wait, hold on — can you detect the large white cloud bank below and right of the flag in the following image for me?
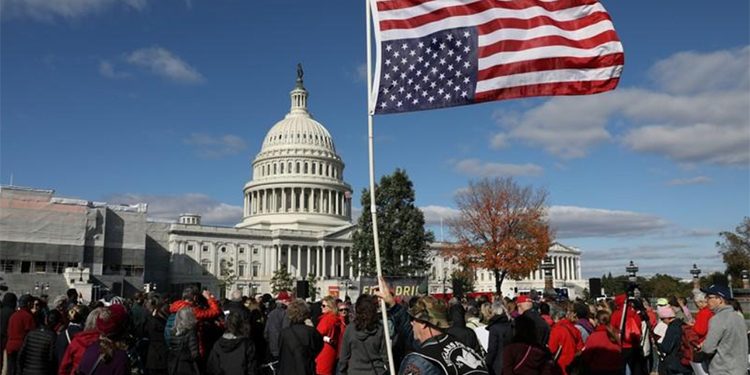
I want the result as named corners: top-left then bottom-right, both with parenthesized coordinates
top-left (490, 47), bottom-right (750, 165)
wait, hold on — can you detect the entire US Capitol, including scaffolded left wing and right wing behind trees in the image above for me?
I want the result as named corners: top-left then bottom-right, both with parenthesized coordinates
top-left (0, 73), bottom-right (587, 298)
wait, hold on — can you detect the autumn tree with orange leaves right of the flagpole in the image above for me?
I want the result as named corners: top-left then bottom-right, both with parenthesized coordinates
top-left (449, 177), bottom-right (553, 293)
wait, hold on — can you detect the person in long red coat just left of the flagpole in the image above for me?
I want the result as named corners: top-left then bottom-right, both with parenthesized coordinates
top-left (315, 296), bottom-right (343, 375)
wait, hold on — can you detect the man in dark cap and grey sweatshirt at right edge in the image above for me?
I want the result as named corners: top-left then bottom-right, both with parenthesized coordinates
top-left (701, 284), bottom-right (747, 375)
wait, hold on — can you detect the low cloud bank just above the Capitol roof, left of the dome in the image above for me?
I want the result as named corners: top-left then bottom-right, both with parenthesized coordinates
top-left (105, 193), bottom-right (242, 226)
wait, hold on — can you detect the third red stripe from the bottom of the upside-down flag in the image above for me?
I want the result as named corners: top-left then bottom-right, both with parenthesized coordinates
top-left (479, 30), bottom-right (617, 57)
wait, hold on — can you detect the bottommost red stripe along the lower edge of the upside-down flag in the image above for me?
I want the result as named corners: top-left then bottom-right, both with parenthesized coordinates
top-left (474, 78), bottom-right (620, 102)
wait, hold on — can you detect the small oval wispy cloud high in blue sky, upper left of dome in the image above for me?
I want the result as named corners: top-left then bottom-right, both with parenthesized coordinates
top-left (126, 47), bottom-right (205, 83)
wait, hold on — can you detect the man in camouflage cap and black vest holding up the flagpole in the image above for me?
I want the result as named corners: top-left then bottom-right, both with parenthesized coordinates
top-left (377, 279), bottom-right (487, 375)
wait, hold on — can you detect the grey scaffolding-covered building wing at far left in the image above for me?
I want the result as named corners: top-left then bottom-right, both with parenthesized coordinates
top-left (0, 186), bottom-right (147, 296)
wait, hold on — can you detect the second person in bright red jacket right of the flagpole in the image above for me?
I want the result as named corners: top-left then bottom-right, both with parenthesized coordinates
top-left (581, 310), bottom-right (623, 375)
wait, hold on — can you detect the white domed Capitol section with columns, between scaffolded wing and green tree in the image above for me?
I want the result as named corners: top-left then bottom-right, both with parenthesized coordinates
top-left (161, 74), bottom-right (355, 294)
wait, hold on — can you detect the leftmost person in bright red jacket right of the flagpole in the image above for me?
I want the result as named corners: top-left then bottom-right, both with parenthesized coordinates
top-left (547, 305), bottom-right (583, 375)
